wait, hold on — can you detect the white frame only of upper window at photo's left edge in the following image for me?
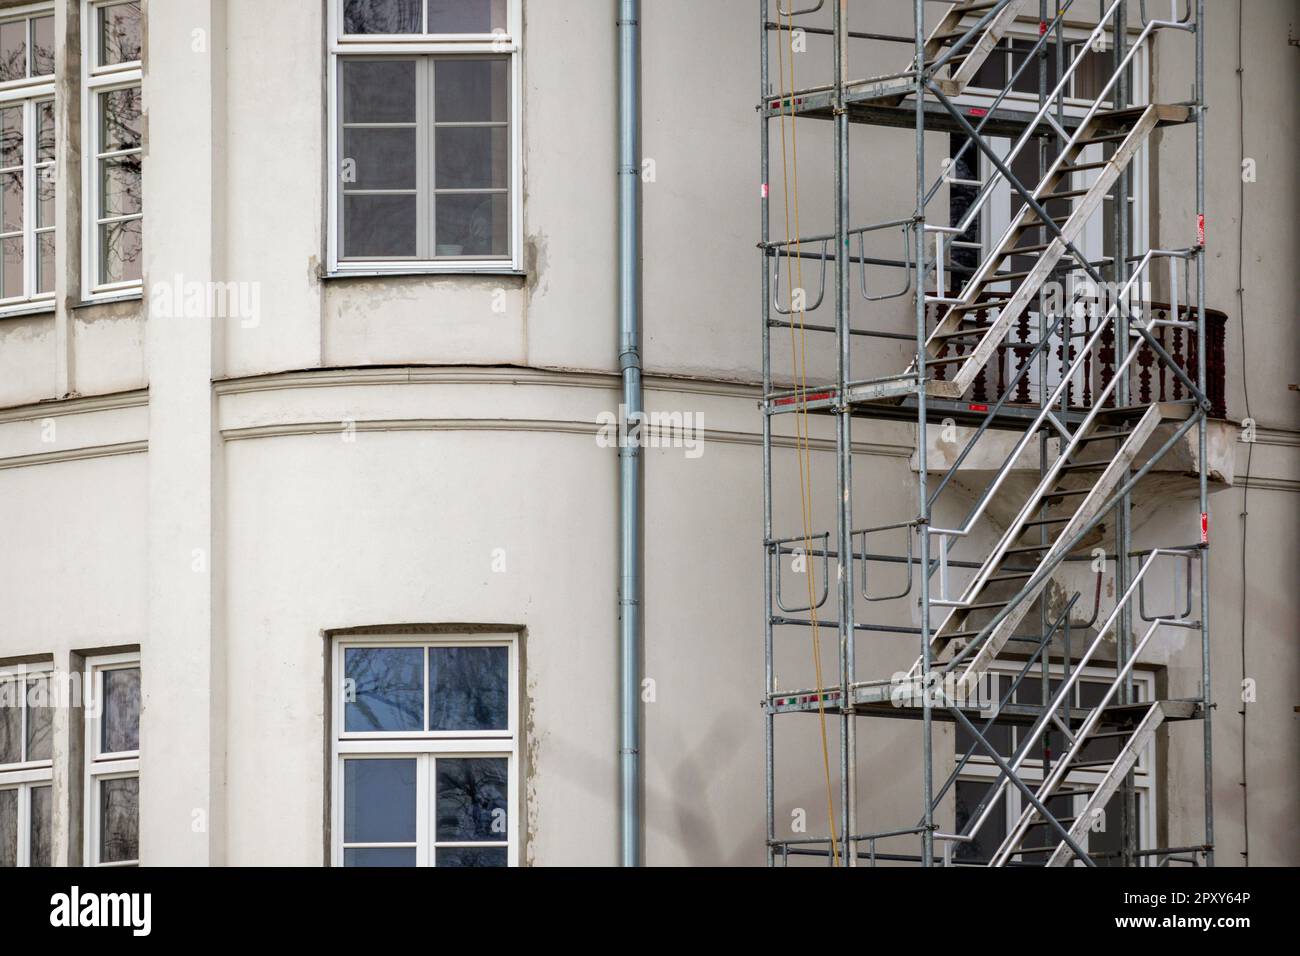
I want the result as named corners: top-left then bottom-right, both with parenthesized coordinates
top-left (0, 3), bottom-right (59, 315)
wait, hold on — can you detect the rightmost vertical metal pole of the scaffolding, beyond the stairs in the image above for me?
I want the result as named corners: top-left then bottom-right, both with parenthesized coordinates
top-left (1196, 0), bottom-right (1214, 866)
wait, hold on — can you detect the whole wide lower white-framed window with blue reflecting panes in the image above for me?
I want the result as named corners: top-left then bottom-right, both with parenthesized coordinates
top-left (330, 636), bottom-right (519, 866)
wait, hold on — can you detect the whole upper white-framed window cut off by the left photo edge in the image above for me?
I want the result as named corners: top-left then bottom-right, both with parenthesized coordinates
top-left (0, 3), bottom-right (55, 311)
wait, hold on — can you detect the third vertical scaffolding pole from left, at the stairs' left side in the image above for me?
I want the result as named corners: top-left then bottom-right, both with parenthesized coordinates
top-left (911, 0), bottom-right (944, 866)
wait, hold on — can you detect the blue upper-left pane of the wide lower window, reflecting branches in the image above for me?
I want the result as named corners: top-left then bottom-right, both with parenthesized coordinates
top-left (343, 648), bottom-right (424, 732)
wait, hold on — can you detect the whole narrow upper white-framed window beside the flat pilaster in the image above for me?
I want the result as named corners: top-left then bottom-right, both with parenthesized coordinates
top-left (82, 0), bottom-right (144, 299)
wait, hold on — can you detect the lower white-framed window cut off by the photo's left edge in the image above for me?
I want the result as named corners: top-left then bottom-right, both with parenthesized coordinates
top-left (0, 665), bottom-right (55, 868)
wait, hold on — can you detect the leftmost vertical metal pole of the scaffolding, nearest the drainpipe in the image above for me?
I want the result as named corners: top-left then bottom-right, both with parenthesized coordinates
top-left (758, 0), bottom-right (780, 866)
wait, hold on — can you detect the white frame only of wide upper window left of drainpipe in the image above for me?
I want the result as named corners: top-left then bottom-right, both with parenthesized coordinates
top-left (325, 0), bottom-right (524, 276)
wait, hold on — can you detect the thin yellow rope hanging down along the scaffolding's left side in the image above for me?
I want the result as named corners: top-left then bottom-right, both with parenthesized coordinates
top-left (776, 5), bottom-right (845, 866)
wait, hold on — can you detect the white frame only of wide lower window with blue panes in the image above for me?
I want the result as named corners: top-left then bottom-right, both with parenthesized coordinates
top-left (329, 633), bottom-right (523, 866)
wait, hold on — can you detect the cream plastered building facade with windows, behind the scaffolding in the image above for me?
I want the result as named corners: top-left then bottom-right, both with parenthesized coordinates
top-left (0, 0), bottom-right (1300, 865)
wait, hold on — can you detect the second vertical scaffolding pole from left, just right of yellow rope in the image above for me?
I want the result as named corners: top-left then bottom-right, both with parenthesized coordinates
top-left (833, 0), bottom-right (858, 866)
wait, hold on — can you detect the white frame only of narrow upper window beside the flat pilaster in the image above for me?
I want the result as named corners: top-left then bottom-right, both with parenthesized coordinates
top-left (81, 0), bottom-right (147, 302)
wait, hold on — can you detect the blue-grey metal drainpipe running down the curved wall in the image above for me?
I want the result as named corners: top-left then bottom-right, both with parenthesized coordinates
top-left (619, 0), bottom-right (644, 866)
